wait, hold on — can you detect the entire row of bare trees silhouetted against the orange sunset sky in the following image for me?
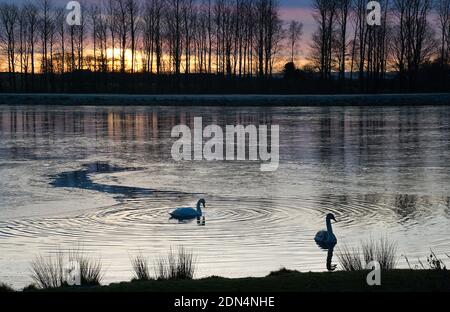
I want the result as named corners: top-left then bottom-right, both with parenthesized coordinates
top-left (0, 0), bottom-right (450, 92)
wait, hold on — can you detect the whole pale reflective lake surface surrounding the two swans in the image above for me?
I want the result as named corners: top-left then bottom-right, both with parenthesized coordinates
top-left (0, 106), bottom-right (450, 287)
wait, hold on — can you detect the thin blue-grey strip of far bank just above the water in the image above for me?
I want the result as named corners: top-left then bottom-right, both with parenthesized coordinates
top-left (0, 93), bottom-right (450, 107)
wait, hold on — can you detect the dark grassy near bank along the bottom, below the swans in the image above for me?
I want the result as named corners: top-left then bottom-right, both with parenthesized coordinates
top-left (37, 270), bottom-right (450, 293)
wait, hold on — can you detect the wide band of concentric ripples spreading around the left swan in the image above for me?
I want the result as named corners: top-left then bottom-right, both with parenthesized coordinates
top-left (0, 194), bottom-right (447, 244)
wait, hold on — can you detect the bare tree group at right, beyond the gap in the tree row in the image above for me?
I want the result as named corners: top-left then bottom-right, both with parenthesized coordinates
top-left (311, 0), bottom-right (450, 88)
